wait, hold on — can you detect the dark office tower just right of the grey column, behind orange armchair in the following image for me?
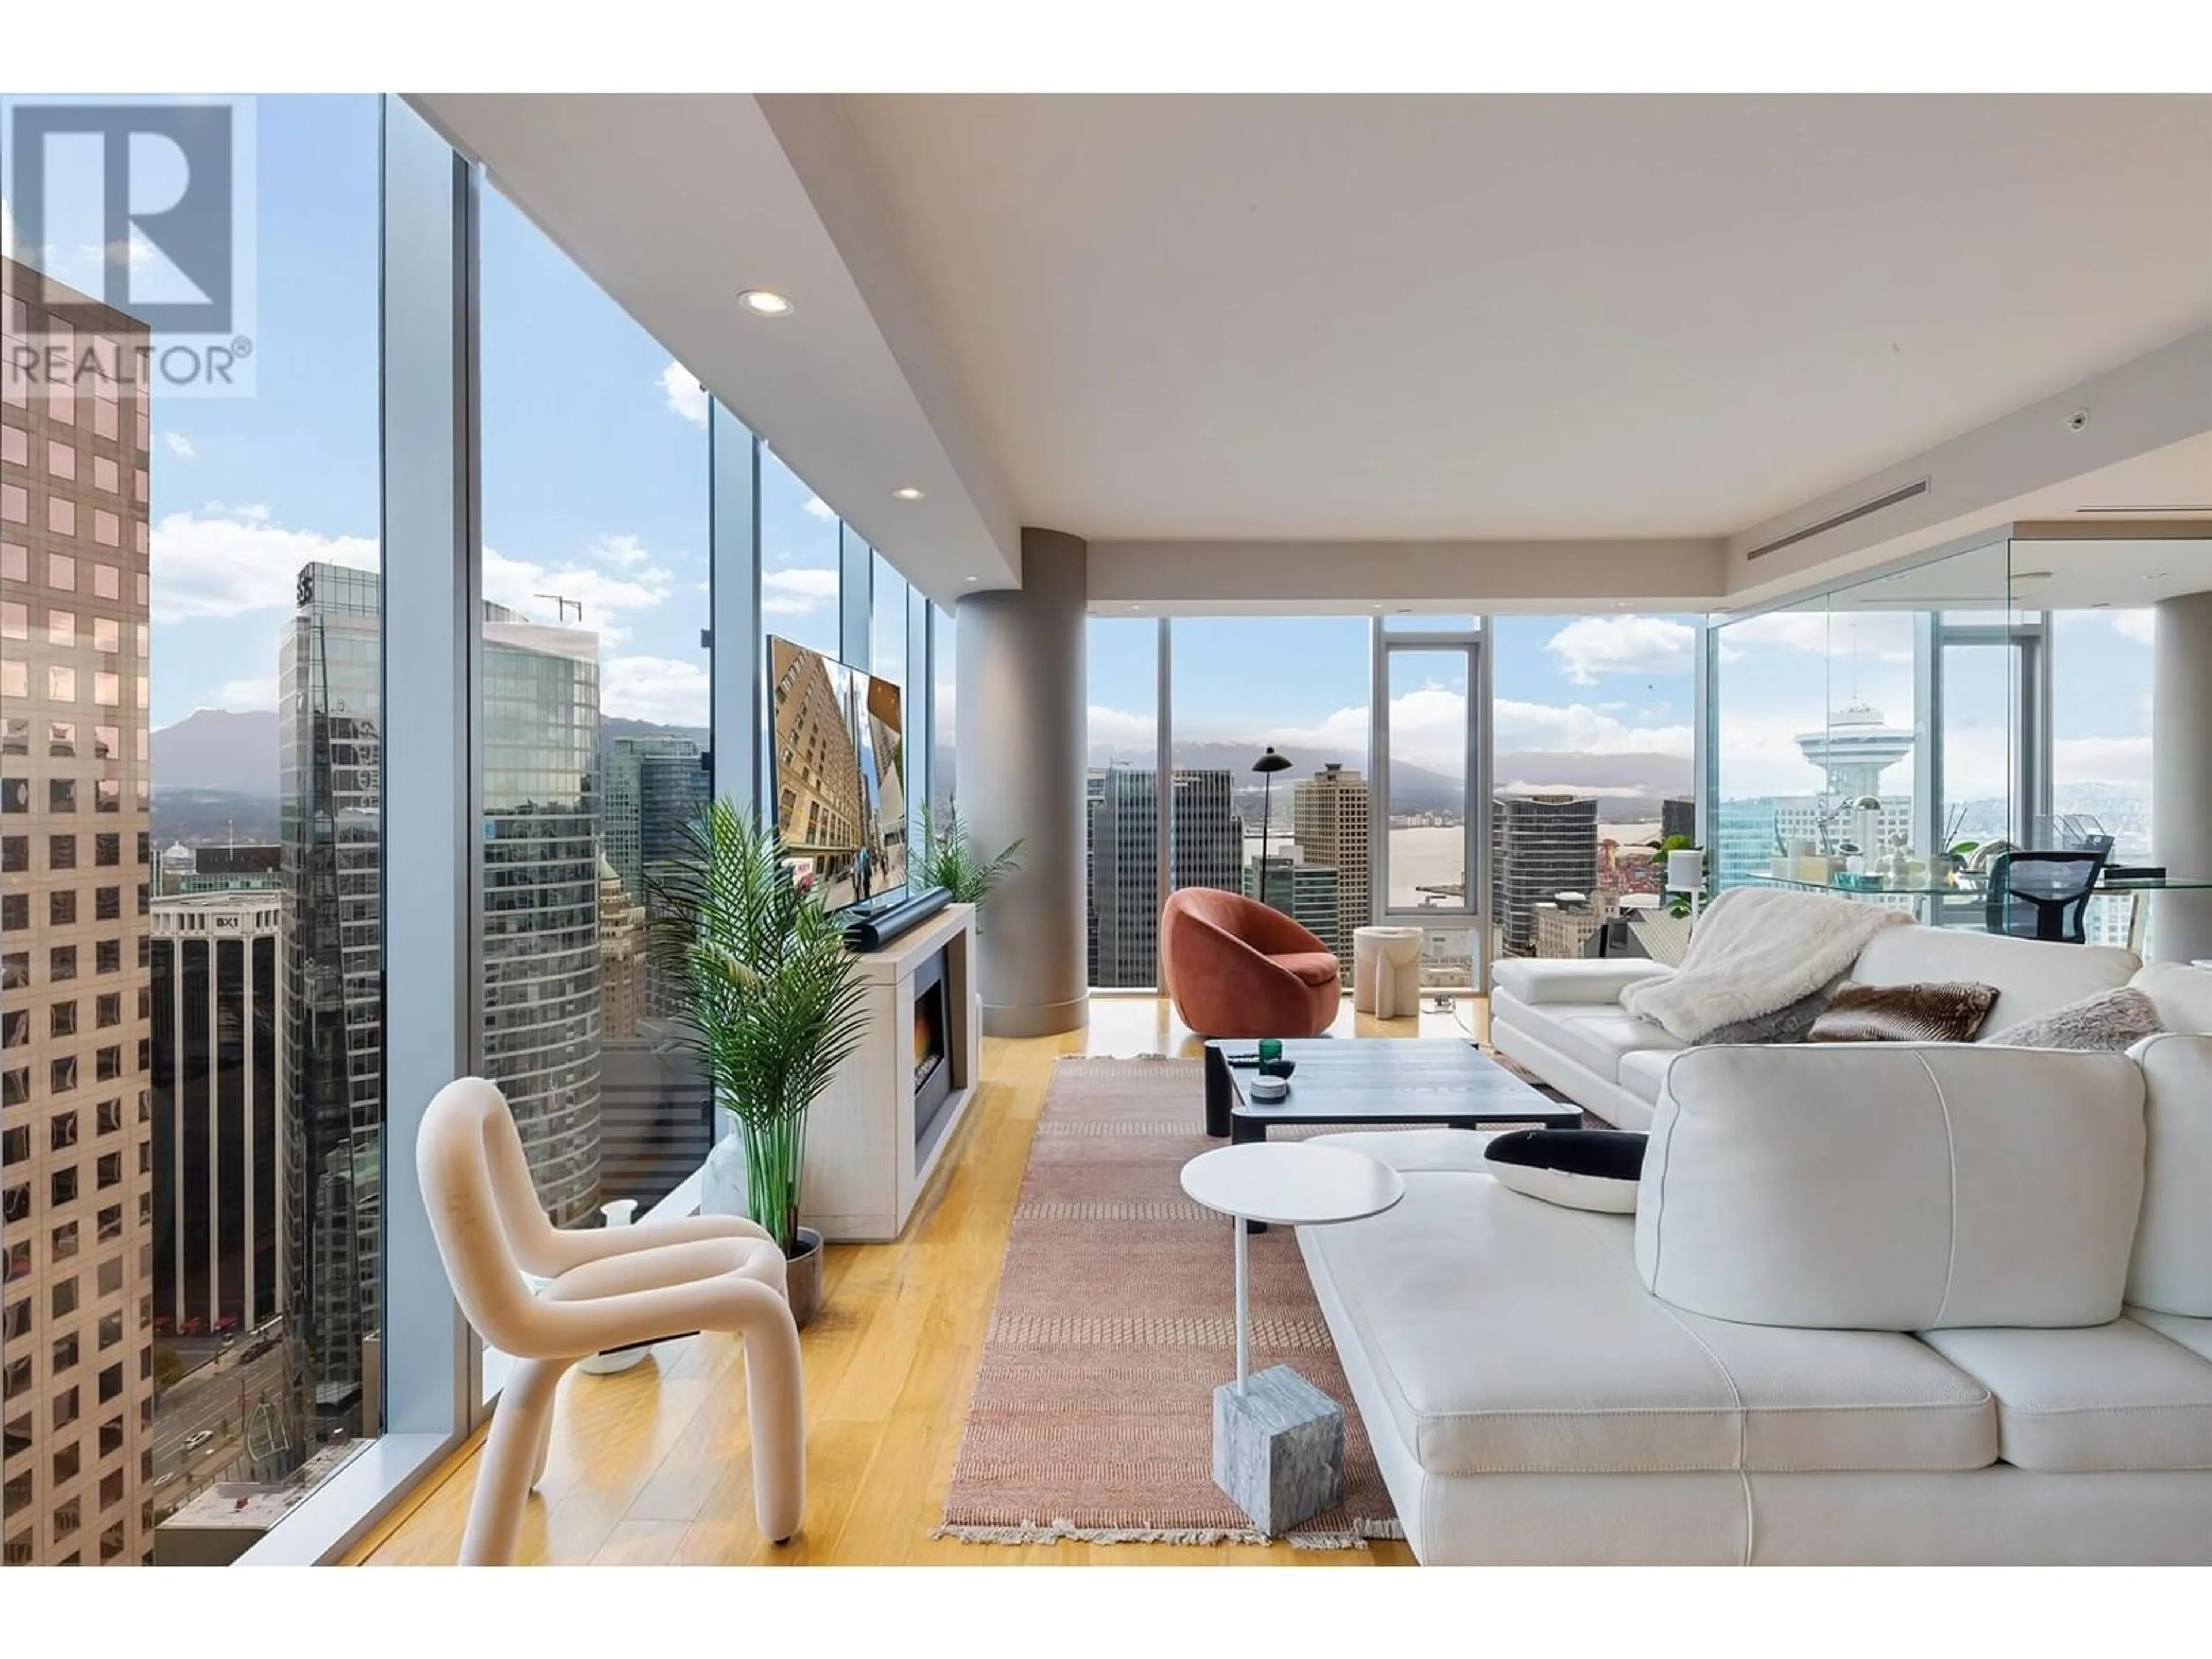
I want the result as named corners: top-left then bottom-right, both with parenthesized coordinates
top-left (1090, 766), bottom-right (1243, 988)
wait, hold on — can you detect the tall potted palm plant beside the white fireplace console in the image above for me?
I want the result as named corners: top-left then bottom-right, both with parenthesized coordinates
top-left (646, 798), bottom-right (867, 1325)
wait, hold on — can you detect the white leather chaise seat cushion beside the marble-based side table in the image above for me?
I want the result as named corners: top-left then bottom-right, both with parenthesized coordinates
top-left (1298, 1168), bottom-right (1998, 1478)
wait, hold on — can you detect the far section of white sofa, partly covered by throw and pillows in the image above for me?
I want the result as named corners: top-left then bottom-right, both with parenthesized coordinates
top-left (1491, 927), bottom-right (2212, 1128)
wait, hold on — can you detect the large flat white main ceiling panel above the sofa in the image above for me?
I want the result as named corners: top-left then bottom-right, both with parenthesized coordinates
top-left (838, 97), bottom-right (2212, 540)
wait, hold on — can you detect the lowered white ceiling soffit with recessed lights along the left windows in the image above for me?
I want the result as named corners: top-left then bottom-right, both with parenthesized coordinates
top-left (411, 93), bottom-right (1020, 604)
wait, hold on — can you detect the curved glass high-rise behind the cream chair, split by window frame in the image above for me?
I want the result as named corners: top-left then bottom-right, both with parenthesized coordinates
top-left (279, 564), bottom-right (600, 1433)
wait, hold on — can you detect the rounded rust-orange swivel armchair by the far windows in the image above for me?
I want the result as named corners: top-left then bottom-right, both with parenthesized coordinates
top-left (1159, 887), bottom-right (1343, 1037)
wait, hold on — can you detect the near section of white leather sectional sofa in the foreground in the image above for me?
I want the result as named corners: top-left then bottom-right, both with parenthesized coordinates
top-left (1298, 942), bottom-right (2212, 1564)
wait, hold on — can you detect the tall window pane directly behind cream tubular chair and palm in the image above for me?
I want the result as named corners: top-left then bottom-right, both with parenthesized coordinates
top-left (478, 184), bottom-right (712, 1389)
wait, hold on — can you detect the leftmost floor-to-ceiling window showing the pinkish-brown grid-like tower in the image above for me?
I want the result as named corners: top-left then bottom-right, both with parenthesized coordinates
top-left (0, 97), bottom-right (382, 1564)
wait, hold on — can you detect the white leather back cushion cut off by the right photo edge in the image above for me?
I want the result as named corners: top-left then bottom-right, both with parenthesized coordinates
top-left (2128, 1035), bottom-right (2212, 1319)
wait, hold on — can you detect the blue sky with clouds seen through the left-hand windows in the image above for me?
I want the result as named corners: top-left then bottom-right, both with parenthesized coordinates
top-left (13, 97), bottom-right (838, 728)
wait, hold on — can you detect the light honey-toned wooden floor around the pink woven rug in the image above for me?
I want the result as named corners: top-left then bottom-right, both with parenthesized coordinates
top-left (350, 998), bottom-right (1484, 1566)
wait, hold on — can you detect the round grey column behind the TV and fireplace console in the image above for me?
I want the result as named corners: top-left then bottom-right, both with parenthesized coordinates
top-left (953, 529), bottom-right (1090, 1037)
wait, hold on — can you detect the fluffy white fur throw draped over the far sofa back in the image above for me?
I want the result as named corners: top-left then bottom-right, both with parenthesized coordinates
top-left (1622, 887), bottom-right (1911, 1042)
